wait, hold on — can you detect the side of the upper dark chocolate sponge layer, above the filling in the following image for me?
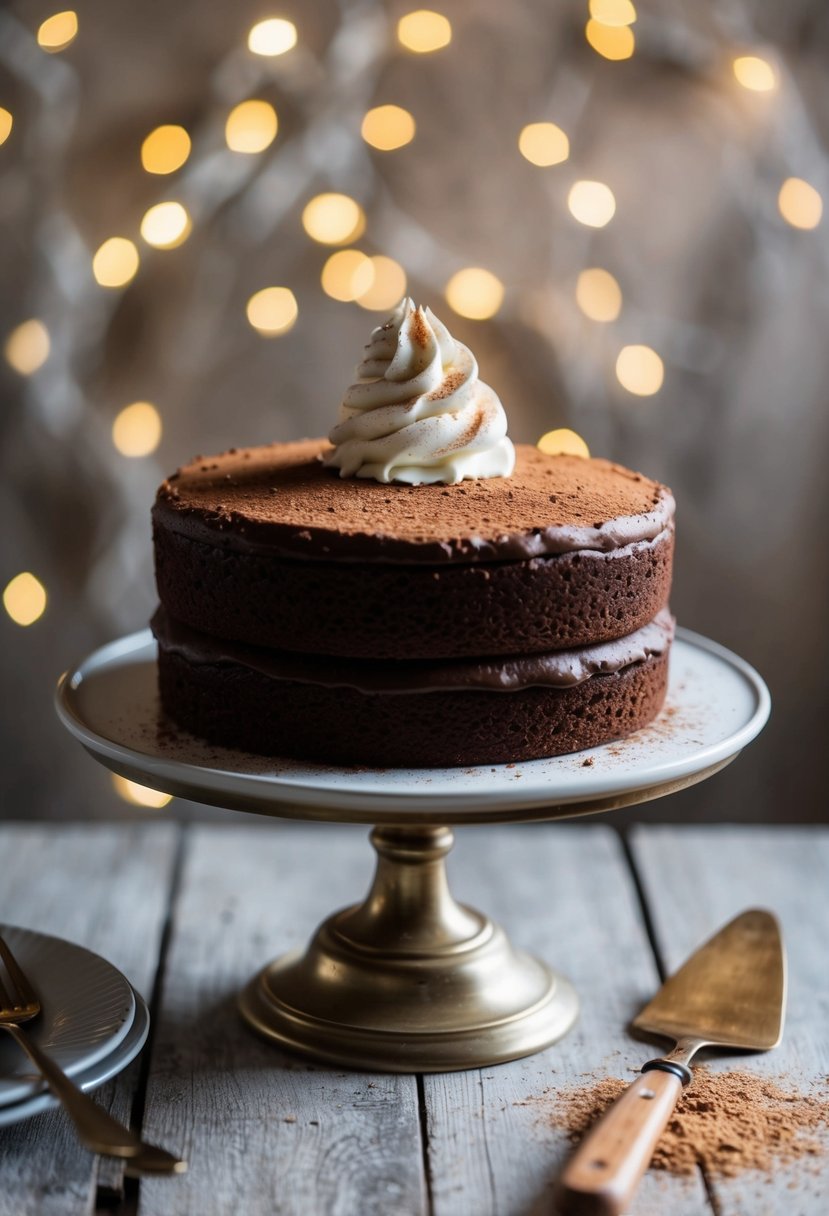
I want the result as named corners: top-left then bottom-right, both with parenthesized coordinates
top-left (154, 524), bottom-right (673, 659)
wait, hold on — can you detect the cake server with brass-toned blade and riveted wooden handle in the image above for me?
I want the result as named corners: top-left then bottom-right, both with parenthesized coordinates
top-left (557, 908), bottom-right (786, 1216)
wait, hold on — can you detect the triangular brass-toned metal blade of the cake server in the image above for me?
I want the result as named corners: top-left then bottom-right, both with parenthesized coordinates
top-left (633, 908), bottom-right (786, 1051)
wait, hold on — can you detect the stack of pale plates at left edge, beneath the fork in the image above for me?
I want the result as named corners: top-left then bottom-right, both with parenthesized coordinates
top-left (0, 924), bottom-right (150, 1127)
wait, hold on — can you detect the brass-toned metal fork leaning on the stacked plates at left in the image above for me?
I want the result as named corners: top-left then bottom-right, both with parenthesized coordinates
top-left (0, 938), bottom-right (187, 1173)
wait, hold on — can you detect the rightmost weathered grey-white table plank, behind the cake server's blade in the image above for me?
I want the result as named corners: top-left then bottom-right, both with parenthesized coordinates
top-left (632, 827), bottom-right (829, 1216)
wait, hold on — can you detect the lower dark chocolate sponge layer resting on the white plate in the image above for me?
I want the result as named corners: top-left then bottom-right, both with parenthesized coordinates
top-left (153, 619), bottom-right (670, 767)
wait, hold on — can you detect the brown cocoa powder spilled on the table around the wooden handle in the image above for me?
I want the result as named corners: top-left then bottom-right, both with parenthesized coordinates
top-left (552, 1065), bottom-right (829, 1177)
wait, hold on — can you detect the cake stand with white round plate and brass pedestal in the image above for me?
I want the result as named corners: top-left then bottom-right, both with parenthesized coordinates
top-left (57, 630), bottom-right (769, 1073)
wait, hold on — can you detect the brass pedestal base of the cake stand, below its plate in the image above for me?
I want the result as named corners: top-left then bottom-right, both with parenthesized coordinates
top-left (239, 827), bottom-right (579, 1073)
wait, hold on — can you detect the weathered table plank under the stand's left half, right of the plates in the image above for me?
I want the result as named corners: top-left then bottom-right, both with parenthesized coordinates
top-left (139, 823), bottom-right (425, 1216)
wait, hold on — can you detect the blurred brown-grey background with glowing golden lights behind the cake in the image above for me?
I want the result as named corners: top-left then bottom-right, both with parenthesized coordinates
top-left (0, 0), bottom-right (829, 821)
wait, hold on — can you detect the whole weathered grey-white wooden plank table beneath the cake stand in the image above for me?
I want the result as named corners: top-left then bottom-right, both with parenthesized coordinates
top-left (0, 821), bottom-right (829, 1216)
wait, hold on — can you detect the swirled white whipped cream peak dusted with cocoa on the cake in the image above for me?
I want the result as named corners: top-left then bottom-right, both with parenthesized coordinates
top-left (325, 298), bottom-right (515, 485)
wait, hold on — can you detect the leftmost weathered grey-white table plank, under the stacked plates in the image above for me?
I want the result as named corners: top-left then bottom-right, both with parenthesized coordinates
top-left (0, 823), bottom-right (176, 1216)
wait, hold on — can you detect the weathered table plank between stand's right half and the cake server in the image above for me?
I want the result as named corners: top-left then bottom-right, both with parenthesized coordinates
top-left (424, 824), bottom-right (710, 1216)
